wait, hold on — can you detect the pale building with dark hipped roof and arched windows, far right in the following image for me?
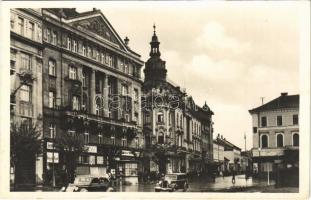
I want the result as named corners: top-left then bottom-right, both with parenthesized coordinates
top-left (249, 93), bottom-right (299, 177)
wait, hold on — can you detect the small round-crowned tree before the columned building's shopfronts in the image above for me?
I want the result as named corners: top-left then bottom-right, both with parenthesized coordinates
top-left (55, 133), bottom-right (86, 183)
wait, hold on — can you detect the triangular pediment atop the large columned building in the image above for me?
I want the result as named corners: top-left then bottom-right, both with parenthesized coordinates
top-left (70, 15), bottom-right (127, 50)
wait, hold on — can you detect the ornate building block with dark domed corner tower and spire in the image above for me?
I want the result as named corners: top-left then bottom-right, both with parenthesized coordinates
top-left (142, 26), bottom-right (213, 173)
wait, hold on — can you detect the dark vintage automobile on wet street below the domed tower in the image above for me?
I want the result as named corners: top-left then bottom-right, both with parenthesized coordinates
top-left (154, 173), bottom-right (189, 192)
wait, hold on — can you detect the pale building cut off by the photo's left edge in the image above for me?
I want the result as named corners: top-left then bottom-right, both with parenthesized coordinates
top-left (10, 9), bottom-right (43, 184)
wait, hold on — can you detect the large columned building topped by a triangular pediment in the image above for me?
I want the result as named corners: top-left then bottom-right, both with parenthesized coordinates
top-left (42, 9), bottom-right (144, 185)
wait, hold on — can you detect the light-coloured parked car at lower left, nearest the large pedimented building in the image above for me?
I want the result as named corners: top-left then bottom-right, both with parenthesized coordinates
top-left (66, 175), bottom-right (115, 192)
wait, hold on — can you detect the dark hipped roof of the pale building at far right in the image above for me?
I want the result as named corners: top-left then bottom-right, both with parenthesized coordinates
top-left (249, 93), bottom-right (299, 114)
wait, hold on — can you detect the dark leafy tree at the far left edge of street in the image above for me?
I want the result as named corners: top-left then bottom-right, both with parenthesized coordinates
top-left (10, 123), bottom-right (41, 188)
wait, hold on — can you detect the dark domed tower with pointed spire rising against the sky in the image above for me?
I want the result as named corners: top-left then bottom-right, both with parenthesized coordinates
top-left (144, 25), bottom-right (167, 89)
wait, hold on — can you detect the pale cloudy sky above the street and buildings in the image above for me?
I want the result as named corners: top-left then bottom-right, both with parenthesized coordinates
top-left (77, 1), bottom-right (300, 150)
